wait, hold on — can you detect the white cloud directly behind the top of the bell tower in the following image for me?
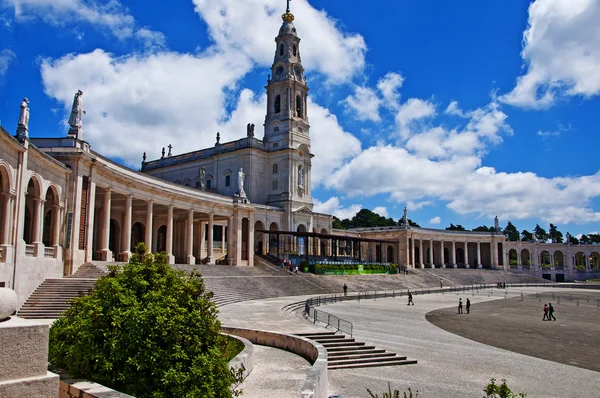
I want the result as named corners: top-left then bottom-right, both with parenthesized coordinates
top-left (193, 0), bottom-right (367, 82)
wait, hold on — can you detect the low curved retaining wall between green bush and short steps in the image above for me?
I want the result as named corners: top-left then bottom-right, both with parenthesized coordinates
top-left (221, 327), bottom-right (328, 398)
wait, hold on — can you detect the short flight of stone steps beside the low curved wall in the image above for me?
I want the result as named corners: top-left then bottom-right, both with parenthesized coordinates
top-left (297, 332), bottom-right (417, 370)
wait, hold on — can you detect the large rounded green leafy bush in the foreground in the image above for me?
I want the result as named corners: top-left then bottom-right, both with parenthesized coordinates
top-left (49, 243), bottom-right (239, 398)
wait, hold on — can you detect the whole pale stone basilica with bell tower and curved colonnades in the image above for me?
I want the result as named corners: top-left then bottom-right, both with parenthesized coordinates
top-left (0, 6), bottom-right (600, 305)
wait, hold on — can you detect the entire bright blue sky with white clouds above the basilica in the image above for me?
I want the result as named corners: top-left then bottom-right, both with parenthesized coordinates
top-left (0, 0), bottom-right (600, 235)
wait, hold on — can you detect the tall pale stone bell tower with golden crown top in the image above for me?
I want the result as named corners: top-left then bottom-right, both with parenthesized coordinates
top-left (263, 1), bottom-right (313, 214)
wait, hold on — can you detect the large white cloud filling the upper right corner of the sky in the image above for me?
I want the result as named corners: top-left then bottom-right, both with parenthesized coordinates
top-left (501, 0), bottom-right (600, 108)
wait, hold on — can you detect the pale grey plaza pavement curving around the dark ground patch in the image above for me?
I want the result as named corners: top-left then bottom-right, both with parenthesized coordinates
top-left (219, 288), bottom-right (600, 398)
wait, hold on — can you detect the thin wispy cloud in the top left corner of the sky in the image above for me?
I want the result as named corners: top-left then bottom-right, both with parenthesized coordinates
top-left (0, 0), bottom-right (164, 48)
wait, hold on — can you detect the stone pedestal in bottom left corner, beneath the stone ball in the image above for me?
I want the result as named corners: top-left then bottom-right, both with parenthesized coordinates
top-left (0, 317), bottom-right (58, 397)
